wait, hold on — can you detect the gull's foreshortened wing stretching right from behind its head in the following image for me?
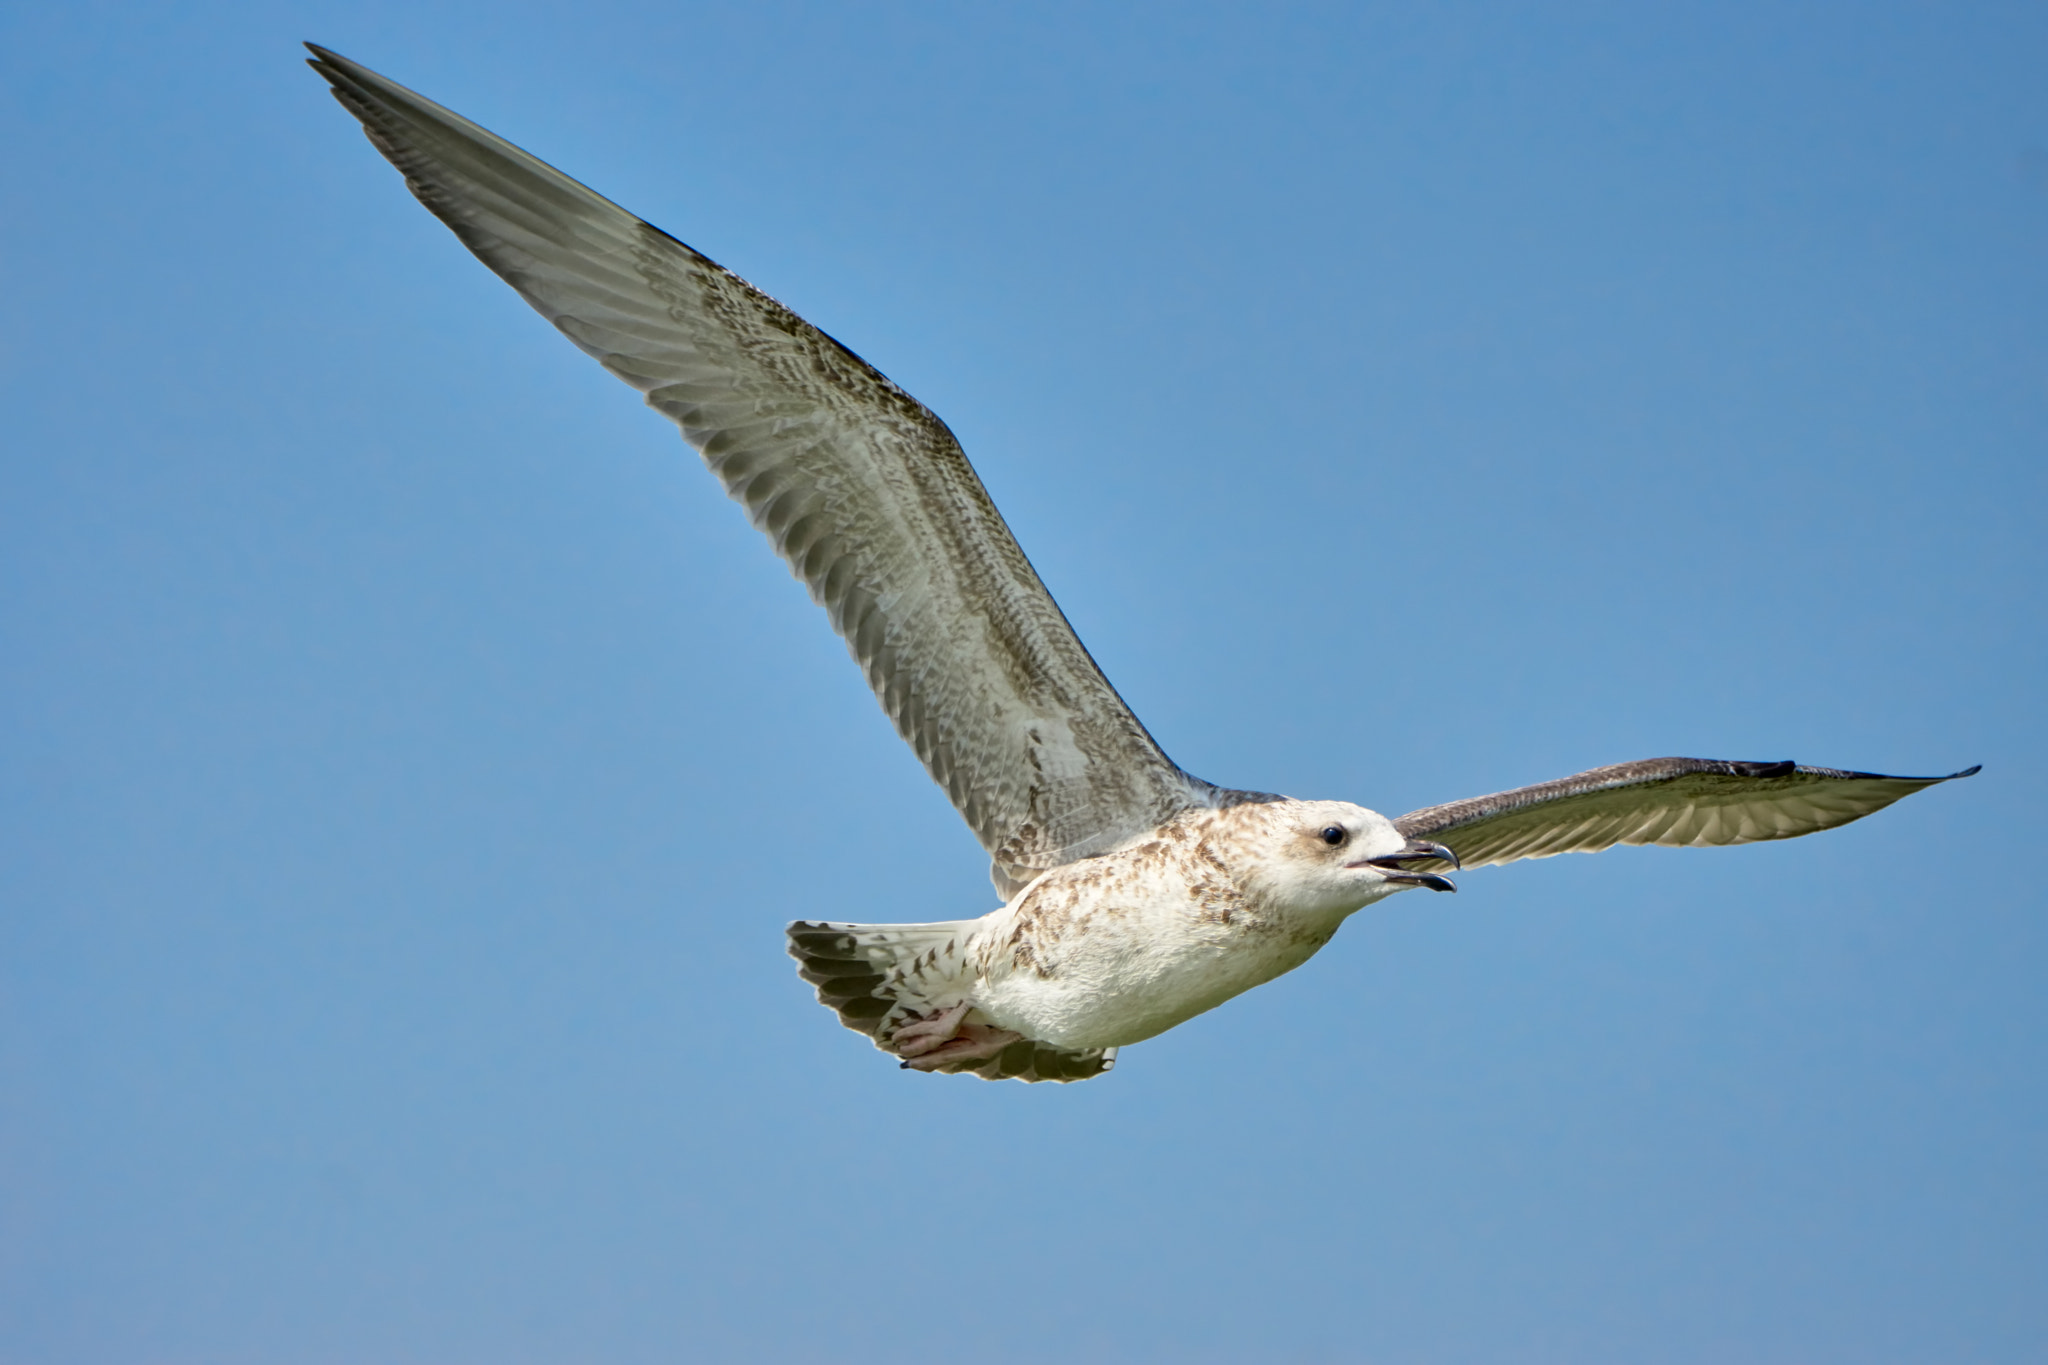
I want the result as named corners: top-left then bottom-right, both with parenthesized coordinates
top-left (1395, 759), bottom-right (1976, 870)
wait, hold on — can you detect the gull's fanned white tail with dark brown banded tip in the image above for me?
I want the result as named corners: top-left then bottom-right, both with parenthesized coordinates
top-left (788, 919), bottom-right (1116, 1081)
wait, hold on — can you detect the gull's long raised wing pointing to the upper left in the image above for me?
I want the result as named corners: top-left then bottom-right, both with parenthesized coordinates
top-left (309, 45), bottom-right (1210, 896)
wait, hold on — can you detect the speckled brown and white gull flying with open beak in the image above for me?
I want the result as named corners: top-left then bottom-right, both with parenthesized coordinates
top-left (307, 43), bottom-right (1978, 1081)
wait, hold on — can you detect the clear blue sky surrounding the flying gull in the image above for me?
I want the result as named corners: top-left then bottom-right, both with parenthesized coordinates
top-left (0, 0), bottom-right (2048, 1365)
